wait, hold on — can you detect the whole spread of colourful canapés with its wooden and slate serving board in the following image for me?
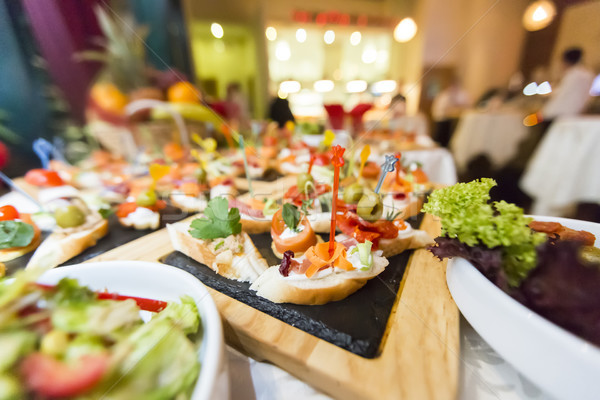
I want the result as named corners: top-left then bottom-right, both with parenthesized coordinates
top-left (1, 134), bottom-right (458, 399)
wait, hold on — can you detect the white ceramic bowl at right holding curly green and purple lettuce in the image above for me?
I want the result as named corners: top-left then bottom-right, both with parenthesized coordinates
top-left (446, 216), bottom-right (600, 400)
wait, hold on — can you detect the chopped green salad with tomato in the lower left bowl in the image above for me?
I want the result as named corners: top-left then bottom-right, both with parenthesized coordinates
top-left (0, 271), bottom-right (201, 400)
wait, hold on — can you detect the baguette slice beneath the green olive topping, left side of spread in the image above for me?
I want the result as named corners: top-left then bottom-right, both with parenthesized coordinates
top-left (26, 218), bottom-right (108, 269)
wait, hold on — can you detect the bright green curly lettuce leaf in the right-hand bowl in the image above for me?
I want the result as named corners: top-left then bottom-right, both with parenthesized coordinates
top-left (423, 178), bottom-right (546, 286)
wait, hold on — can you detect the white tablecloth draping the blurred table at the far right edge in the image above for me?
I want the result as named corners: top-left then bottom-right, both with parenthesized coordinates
top-left (520, 116), bottom-right (600, 216)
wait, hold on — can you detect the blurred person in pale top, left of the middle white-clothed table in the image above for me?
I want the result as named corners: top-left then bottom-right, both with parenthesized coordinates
top-left (431, 78), bottom-right (471, 147)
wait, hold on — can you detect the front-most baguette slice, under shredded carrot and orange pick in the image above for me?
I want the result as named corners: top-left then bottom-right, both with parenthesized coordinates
top-left (250, 256), bottom-right (388, 305)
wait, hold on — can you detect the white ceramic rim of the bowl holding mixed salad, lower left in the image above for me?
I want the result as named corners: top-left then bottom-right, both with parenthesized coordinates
top-left (38, 261), bottom-right (229, 400)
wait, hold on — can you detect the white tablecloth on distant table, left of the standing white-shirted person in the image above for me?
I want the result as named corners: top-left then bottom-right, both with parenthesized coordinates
top-left (450, 111), bottom-right (529, 171)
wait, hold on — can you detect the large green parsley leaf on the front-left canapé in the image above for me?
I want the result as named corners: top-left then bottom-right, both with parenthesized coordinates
top-left (190, 197), bottom-right (242, 239)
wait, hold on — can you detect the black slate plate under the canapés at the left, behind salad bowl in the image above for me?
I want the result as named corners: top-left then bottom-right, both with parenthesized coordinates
top-left (4, 205), bottom-right (192, 275)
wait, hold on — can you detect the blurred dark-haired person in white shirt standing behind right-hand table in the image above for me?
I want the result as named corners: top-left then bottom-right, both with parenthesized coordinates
top-left (540, 48), bottom-right (594, 121)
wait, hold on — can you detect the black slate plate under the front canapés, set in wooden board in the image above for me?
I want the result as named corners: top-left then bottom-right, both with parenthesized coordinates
top-left (161, 215), bottom-right (423, 358)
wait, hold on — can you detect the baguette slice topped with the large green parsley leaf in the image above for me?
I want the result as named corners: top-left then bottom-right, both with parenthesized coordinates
top-left (167, 221), bottom-right (269, 282)
